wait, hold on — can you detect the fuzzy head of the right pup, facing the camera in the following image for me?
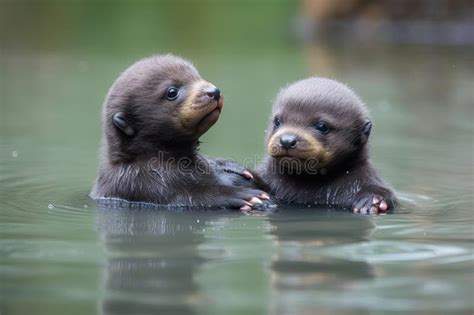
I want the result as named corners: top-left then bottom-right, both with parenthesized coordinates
top-left (267, 78), bottom-right (372, 174)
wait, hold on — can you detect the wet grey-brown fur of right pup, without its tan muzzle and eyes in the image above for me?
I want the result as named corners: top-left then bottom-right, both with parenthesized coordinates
top-left (257, 78), bottom-right (395, 209)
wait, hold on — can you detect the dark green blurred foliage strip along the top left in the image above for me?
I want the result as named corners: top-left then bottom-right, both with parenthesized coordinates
top-left (1, 0), bottom-right (297, 54)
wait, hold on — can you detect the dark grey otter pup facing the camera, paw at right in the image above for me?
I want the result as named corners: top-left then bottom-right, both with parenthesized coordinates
top-left (259, 77), bottom-right (395, 214)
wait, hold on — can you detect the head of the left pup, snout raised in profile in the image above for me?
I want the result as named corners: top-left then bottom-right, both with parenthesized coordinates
top-left (103, 55), bottom-right (224, 158)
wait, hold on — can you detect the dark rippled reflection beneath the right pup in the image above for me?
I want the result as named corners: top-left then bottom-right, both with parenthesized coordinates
top-left (269, 209), bottom-right (374, 314)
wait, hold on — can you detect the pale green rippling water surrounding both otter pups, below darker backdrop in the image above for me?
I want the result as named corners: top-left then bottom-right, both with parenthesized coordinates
top-left (0, 1), bottom-right (474, 314)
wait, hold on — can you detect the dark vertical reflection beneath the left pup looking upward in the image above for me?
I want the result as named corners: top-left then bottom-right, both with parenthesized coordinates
top-left (98, 209), bottom-right (215, 314)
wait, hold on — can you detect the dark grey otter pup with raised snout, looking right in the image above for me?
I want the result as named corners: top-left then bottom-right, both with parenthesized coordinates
top-left (90, 55), bottom-right (269, 210)
